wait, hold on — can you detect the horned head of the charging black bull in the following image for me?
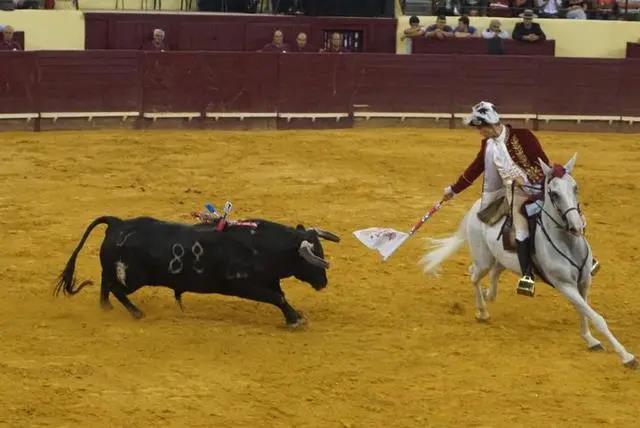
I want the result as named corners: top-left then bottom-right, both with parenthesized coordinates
top-left (294, 225), bottom-right (340, 290)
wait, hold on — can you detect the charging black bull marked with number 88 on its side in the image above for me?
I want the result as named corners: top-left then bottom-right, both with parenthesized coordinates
top-left (55, 216), bottom-right (340, 325)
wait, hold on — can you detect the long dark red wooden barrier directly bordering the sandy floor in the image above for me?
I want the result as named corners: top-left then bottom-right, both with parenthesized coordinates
top-left (0, 50), bottom-right (640, 128)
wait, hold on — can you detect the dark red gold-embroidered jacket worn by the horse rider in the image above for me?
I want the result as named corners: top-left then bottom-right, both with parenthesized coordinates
top-left (451, 125), bottom-right (549, 193)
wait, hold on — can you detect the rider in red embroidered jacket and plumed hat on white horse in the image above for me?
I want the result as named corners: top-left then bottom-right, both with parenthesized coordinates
top-left (444, 101), bottom-right (549, 297)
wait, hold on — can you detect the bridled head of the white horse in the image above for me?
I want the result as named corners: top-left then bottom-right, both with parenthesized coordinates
top-left (538, 154), bottom-right (585, 235)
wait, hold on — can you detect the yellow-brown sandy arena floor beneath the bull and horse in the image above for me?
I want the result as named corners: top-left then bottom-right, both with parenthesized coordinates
top-left (0, 130), bottom-right (640, 427)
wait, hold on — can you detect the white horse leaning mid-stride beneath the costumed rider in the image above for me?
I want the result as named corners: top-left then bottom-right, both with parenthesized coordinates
top-left (421, 155), bottom-right (638, 369)
